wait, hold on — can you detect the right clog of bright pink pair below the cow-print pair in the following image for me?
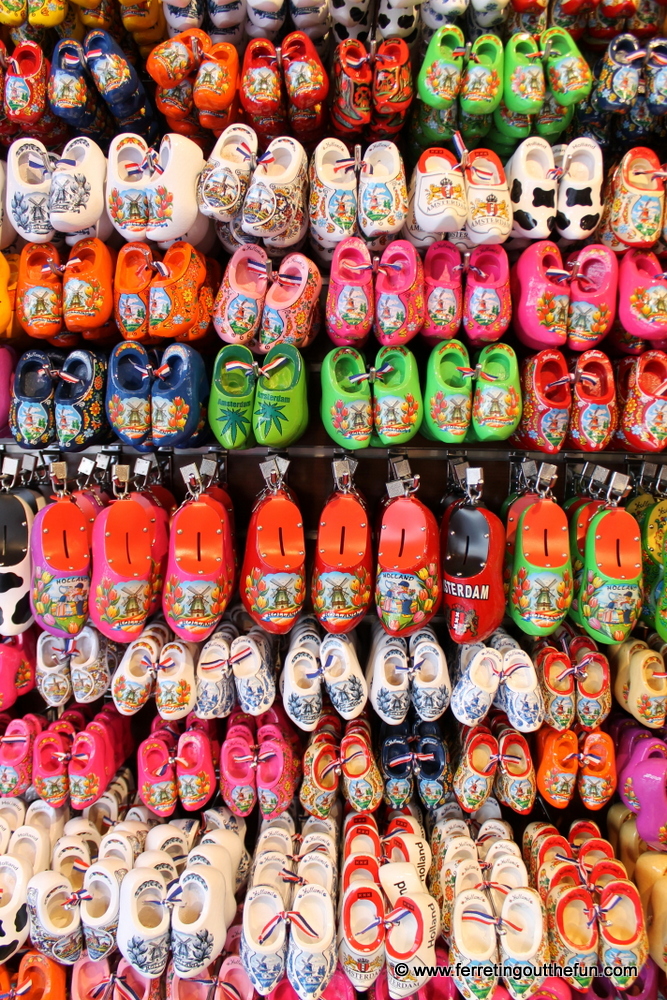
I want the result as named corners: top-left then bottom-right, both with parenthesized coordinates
top-left (566, 243), bottom-right (618, 351)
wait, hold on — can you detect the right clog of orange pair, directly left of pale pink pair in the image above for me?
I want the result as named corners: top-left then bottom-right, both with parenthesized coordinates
top-left (148, 240), bottom-right (206, 337)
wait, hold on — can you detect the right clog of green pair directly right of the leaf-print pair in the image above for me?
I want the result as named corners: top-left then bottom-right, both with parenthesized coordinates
top-left (373, 346), bottom-right (424, 446)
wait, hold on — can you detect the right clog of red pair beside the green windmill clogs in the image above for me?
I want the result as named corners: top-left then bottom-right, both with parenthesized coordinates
top-left (566, 350), bottom-right (618, 451)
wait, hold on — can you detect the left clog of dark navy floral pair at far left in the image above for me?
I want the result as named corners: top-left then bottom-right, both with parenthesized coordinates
top-left (9, 351), bottom-right (64, 448)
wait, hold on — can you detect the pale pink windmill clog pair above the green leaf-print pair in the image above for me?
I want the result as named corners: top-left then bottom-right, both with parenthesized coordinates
top-left (213, 243), bottom-right (322, 354)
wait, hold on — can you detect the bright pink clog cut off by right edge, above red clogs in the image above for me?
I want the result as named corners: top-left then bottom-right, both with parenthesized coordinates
top-left (618, 250), bottom-right (667, 340)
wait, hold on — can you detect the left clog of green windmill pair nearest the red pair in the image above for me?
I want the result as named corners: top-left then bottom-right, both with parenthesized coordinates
top-left (422, 340), bottom-right (472, 444)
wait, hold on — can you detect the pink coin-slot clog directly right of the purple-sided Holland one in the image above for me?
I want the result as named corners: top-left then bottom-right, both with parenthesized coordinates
top-left (90, 497), bottom-right (152, 642)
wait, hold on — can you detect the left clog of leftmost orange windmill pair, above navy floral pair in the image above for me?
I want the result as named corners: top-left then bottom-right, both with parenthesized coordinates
top-left (16, 243), bottom-right (63, 339)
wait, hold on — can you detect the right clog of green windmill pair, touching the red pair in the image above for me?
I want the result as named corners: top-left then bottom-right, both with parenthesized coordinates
top-left (471, 344), bottom-right (521, 441)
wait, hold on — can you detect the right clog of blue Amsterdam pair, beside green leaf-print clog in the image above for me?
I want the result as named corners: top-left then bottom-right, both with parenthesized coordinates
top-left (151, 344), bottom-right (208, 448)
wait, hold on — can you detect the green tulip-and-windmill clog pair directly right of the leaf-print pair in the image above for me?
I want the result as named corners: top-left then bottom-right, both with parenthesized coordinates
top-left (321, 346), bottom-right (423, 449)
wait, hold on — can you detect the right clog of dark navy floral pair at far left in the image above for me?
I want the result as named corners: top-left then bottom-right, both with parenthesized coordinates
top-left (54, 351), bottom-right (107, 451)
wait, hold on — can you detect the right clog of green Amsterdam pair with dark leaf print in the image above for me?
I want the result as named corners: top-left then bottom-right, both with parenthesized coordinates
top-left (252, 344), bottom-right (308, 448)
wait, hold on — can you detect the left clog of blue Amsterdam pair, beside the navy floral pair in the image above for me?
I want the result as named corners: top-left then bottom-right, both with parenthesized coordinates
top-left (106, 340), bottom-right (157, 448)
